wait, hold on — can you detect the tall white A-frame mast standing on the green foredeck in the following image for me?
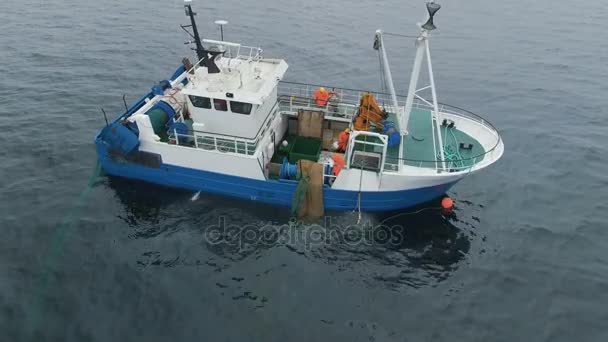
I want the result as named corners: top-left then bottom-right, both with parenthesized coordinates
top-left (400, 1), bottom-right (445, 169)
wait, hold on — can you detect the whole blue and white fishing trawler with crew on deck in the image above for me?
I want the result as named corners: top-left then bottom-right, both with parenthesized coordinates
top-left (95, 0), bottom-right (504, 212)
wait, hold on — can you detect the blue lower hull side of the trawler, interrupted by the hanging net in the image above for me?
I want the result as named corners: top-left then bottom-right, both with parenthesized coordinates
top-left (96, 140), bottom-right (455, 212)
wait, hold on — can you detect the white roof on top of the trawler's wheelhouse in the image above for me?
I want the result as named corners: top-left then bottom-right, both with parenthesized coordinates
top-left (183, 57), bottom-right (288, 105)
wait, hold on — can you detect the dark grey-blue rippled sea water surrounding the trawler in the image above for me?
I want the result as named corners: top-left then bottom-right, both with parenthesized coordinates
top-left (0, 0), bottom-right (608, 342)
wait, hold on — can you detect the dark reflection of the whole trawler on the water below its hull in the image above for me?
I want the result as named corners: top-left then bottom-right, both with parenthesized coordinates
top-left (108, 178), bottom-right (479, 290)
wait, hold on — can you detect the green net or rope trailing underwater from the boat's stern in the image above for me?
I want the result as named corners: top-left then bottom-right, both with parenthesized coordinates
top-left (29, 161), bottom-right (101, 341)
